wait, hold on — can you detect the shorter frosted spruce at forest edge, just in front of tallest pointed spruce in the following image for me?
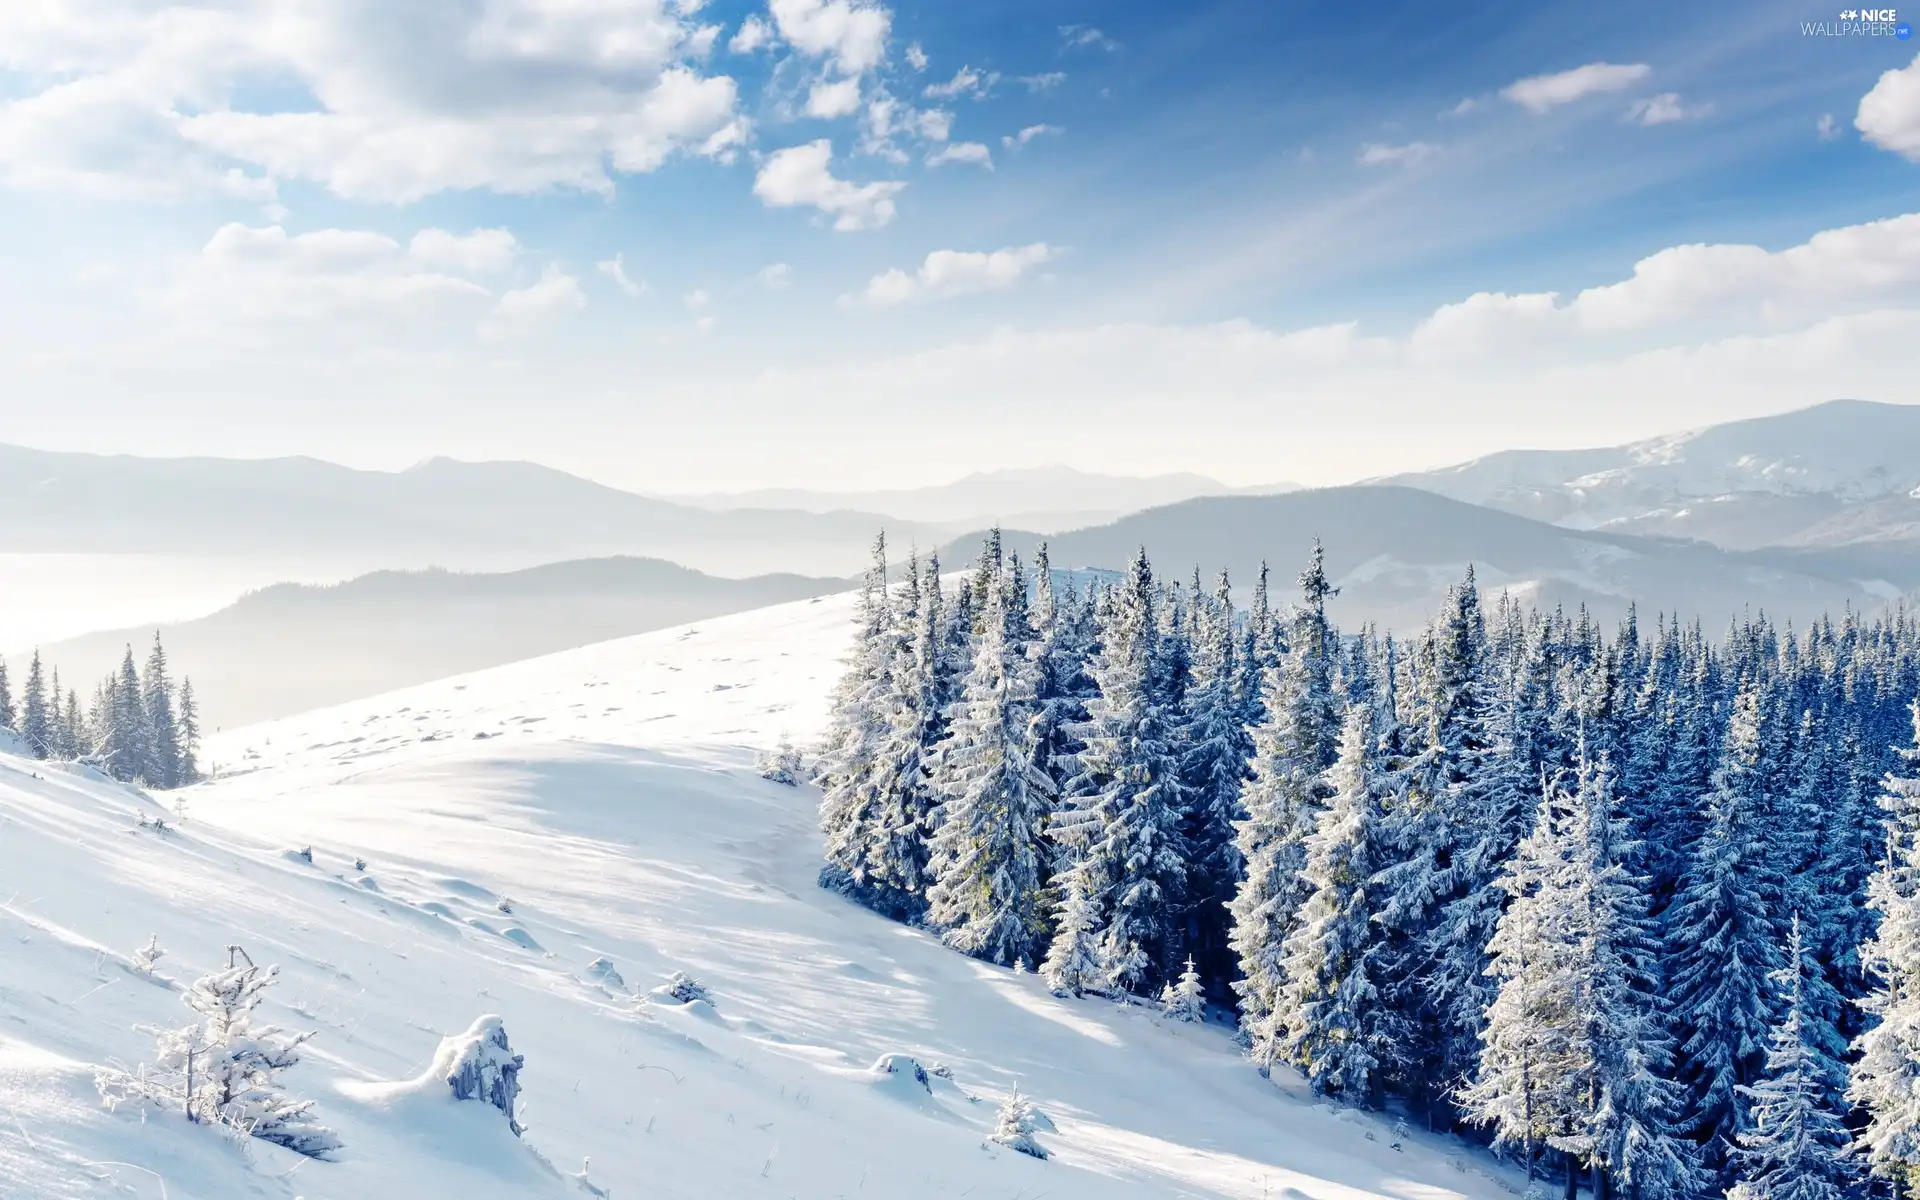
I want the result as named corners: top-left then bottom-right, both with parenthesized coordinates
top-left (1279, 705), bottom-right (1394, 1104)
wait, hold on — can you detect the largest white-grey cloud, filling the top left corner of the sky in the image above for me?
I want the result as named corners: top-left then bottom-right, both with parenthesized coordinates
top-left (0, 0), bottom-right (735, 202)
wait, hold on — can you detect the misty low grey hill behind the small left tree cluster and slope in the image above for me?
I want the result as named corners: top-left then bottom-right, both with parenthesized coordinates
top-left (33, 559), bottom-right (847, 730)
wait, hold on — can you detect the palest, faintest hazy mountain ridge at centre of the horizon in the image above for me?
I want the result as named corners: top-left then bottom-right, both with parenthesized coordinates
top-left (666, 467), bottom-right (1298, 532)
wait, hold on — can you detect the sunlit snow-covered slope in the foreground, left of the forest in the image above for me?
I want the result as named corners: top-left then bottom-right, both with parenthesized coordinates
top-left (0, 597), bottom-right (1515, 1200)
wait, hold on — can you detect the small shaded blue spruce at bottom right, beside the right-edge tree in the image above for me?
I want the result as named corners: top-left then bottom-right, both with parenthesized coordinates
top-left (1728, 916), bottom-right (1855, 1200)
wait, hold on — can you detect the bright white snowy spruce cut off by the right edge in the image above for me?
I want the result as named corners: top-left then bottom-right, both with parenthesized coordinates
top-left (1847, 703), bottom-right (1920, 1196)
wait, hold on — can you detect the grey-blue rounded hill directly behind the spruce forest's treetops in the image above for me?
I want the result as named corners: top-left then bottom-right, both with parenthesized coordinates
top-left (943, 486), bottom-right (1920, 630)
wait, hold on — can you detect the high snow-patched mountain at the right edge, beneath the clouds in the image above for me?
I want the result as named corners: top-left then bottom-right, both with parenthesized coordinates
top-left (1377, 399), bottom-right (1920, 549)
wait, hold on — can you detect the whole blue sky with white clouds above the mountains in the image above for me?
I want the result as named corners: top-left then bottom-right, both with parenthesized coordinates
top-left (0, 0), bottom-right (1920, 490)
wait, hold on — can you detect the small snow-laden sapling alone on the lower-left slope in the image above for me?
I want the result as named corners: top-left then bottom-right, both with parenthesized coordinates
top-left (98, 947), bottom-right (340, 1158)
